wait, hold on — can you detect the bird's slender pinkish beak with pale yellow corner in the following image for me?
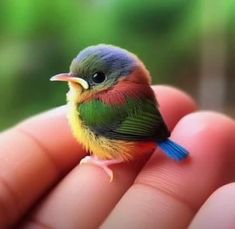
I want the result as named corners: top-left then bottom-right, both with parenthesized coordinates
top-left (50, 73), bottom-right (89, 90)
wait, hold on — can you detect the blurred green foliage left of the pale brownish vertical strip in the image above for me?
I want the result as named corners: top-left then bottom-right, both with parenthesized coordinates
top-left (0, 0), bottom-right (235, 129)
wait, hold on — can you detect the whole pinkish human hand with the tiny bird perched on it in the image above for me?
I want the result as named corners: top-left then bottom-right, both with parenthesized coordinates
top-left (0, 86), bottom-right (235, 229)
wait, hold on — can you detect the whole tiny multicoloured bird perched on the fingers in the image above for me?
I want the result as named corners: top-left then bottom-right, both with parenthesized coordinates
top-left (51, 44), bottom-right (188, 180)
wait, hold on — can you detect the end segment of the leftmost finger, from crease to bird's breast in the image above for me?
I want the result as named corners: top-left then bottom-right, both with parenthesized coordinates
top-left (15, 106), bottom-right (85, 171)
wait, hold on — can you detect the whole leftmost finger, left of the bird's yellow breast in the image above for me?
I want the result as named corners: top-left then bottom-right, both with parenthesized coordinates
top-left (0, 106), bottom-right (85, 228)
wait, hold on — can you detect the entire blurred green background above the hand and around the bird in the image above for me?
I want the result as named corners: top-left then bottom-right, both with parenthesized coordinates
top-left (0, 0), bottom-right (235, 130)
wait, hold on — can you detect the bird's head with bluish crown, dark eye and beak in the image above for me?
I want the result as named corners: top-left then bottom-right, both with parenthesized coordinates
top-left (51, 44), bottom-right (150, 102)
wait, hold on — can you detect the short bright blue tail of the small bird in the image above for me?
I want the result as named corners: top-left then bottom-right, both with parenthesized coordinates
top-left (157, 139), bottom-right (189, 161)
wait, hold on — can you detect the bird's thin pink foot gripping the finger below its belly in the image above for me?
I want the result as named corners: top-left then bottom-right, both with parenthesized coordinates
top-left (80, 156), bottom-right (124, 183)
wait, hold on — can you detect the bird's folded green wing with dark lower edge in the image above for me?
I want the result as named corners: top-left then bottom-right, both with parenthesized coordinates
top-left (78, 98), bottom-right (169, 141)
